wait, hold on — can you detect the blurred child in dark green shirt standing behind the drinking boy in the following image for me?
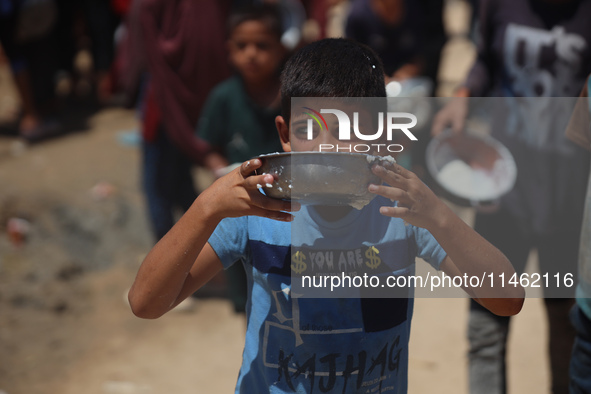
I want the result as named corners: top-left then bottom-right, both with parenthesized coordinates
top-left (198, 5), bottom-right (285, 312)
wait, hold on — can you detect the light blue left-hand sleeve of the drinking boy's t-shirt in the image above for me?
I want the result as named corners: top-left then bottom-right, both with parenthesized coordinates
top-left (208, 216), bottom-right (248, 269)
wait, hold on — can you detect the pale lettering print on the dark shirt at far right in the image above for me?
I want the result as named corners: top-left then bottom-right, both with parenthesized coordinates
top-left (503, 24), bottom-right (587, 154)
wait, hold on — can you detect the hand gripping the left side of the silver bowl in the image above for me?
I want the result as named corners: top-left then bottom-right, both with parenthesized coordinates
top-left (199, 159), bottom-right (300, 222)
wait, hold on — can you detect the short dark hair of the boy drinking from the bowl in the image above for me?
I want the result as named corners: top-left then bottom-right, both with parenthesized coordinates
top-left (281, 38), bottom-right (386, 124)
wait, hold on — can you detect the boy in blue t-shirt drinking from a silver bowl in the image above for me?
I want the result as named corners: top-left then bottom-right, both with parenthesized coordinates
top-left (129, 39), bottom-right (524, 393)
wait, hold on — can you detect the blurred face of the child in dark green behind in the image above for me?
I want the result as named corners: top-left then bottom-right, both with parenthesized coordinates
top-left (228, 21), bottom-right (284, 82)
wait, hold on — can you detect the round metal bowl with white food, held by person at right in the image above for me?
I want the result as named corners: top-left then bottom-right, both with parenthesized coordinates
top-left (426, 131), bottom-right (517, 207)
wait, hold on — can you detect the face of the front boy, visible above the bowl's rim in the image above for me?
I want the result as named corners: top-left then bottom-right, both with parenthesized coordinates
top-left (275, 105), bottom-right (373, 153)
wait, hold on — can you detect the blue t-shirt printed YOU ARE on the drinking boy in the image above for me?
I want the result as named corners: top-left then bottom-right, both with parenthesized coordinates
top-left (209, 197), bottom-right (446, 393)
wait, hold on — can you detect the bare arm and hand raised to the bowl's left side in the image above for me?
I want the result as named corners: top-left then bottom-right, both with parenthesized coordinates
top-left (129, 159), bottom-right (299, 319)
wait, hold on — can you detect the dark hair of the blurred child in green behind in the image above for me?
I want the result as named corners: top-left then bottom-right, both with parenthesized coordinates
top-left (227, 4), bottom-right (283, 40)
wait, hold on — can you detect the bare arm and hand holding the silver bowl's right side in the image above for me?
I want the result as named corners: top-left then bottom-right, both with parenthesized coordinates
top-left (369, 164), bottom-right (525, 316)
